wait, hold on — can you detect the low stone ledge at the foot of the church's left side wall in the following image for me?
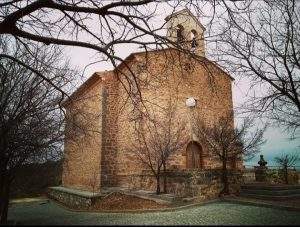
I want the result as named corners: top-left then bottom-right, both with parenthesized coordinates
top-left (48, 187), bottom-right (102, 209)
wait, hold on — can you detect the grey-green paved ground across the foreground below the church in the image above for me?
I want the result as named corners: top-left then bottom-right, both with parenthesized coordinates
top-left (9, 201), bottom-right (300, 225)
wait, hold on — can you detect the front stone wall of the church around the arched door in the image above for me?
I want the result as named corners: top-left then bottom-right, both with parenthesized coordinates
top-left (109, 49), bottom-right (241, 185)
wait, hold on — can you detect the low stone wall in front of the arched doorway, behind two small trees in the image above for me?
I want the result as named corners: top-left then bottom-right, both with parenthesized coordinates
top-left (113, 170), bottom-right (242, 200)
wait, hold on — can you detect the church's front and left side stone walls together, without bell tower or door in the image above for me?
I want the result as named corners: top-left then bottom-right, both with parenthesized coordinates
top-left (63, 49), bottom-right (240, 193)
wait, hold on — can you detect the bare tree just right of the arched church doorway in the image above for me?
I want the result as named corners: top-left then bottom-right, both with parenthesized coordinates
top-left (194, 113), bottom-right (266, 195)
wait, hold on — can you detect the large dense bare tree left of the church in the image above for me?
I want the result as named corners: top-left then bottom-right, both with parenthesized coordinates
top-left (0, 39), bottom-right (70, 223)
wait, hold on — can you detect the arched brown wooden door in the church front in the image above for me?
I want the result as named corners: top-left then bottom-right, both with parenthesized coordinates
top-left (186, 141), bottom-right (203, 169)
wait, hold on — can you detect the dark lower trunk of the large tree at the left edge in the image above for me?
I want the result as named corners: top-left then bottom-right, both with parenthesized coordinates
top-left (0, 176), bottom-right (10, 224)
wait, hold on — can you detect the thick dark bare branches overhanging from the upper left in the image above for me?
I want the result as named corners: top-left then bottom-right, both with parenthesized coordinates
top-left (0, 0), bottom-right (239, 94)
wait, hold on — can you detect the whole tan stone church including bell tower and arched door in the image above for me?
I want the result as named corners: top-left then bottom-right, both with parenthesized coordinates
top-left (62, 9), bottom-right (242, 197)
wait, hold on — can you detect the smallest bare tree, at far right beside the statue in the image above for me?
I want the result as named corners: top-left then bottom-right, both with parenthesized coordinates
top-left (274, 154), bottom-right (300, 184)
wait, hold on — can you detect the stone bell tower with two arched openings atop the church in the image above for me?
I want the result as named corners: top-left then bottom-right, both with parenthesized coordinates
top-left (165, 9), bottom-right (205, 57)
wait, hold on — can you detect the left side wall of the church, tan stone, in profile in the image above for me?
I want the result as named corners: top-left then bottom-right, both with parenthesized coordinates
top-left (62, 72), bottom-right (109, 191)
